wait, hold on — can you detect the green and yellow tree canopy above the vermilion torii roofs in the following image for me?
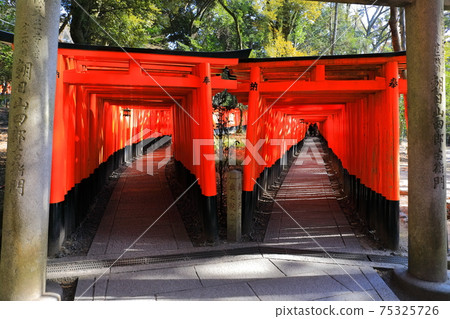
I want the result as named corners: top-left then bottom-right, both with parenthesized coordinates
top-left (0, 0), bottom-right (414, 57)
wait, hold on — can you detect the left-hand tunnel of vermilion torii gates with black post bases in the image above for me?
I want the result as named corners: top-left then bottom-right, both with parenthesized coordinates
top-left (49, 44), bottom-right (250, 251)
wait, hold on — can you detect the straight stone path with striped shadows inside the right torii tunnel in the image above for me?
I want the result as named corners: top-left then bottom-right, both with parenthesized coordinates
top-left (264, 137), bottom-right (361, 251)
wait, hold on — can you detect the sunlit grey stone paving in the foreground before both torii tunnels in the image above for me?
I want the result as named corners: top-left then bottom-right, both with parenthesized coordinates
top-left (76, 255), bottom-right (398, 301)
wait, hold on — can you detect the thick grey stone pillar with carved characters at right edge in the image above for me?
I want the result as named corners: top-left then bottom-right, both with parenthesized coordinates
top-left (406, 0), bottom-right (447, 282)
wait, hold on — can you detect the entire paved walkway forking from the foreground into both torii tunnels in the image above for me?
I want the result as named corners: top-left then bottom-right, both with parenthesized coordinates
top-left (70, 138), bottom-right (397, 301)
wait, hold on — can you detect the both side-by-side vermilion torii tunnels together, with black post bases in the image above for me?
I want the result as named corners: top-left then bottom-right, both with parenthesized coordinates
top-left (44, 45), bottom-right (406, 254)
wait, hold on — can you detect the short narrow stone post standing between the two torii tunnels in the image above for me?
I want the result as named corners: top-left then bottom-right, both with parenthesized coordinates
top-left (227, 170), bottom-right (242, 241)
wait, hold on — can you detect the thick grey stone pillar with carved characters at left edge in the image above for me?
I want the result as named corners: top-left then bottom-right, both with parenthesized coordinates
top-left (0, 0), bottom-right (60, 300)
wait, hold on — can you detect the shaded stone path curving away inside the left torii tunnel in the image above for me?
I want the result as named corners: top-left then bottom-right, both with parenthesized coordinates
top-left (88, 146), bottom-right (192, 258)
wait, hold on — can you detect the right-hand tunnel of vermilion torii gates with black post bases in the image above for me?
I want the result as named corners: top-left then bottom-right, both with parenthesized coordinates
top-left (231, 53), bottom-right (407, 249)
